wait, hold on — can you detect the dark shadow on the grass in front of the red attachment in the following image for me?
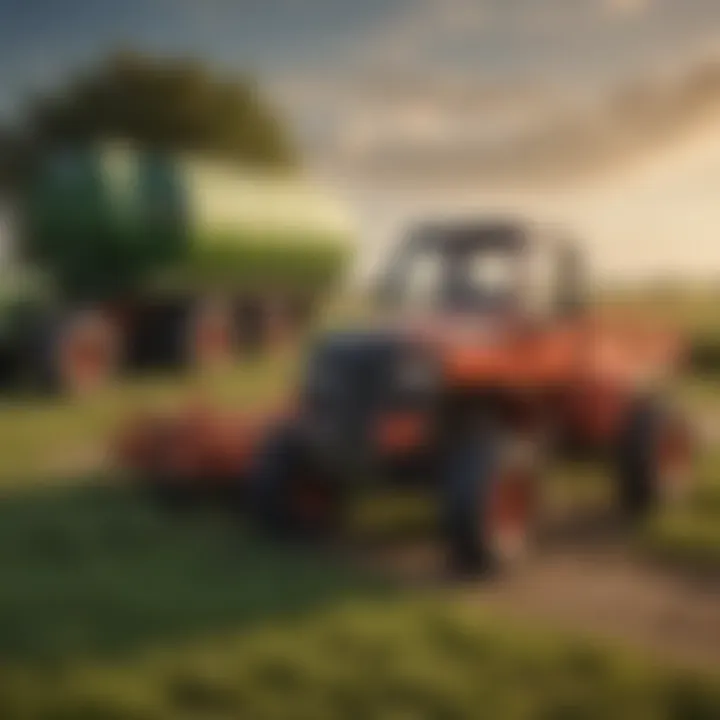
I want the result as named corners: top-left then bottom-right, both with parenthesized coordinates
top-left (0, 485), bottom-right (383, 662)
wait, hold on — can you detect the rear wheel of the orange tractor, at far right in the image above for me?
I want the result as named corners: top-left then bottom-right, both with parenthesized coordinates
top-left (616, 398), bottom-right (693, 519)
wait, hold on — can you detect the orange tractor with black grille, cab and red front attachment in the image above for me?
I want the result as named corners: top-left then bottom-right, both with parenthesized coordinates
top-left (122, 218), bottom-right (693, 570)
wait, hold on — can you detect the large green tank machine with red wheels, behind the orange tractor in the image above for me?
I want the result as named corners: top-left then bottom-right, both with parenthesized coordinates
top-left (0, 145), bottom-right (349, 393)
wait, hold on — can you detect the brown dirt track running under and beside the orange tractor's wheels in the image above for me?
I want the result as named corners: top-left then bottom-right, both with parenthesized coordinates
top-left (362, 506), bottom-right (720, 668)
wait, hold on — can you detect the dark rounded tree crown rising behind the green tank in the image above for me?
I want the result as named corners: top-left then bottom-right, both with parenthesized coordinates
top-left (25, 52), bottom-right (293, 167)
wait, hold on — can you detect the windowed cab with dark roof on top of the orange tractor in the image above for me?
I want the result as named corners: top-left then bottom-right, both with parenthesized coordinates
top-left (380, 220), bottom-right (584, 317)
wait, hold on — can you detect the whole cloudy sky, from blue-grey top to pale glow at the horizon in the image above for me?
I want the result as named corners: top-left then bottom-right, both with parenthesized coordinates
top-left (0, 0), bottom-right (720, 274)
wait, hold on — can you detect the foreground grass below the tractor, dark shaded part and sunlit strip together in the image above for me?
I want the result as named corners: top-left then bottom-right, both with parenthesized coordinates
top-left (0, 466), bottom-right (720, 720)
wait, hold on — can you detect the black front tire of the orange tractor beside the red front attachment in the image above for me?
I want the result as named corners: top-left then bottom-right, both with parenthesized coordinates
top-left (248, 426), bottom-right (343, 540)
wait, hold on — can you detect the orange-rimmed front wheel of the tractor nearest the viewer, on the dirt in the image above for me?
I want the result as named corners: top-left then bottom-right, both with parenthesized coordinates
top-left (441, 430), bottom-right (538, 574)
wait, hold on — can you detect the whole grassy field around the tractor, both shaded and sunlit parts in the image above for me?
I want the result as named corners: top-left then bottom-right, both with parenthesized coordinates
top-left (0, 292), bottom-right (720, 720)
